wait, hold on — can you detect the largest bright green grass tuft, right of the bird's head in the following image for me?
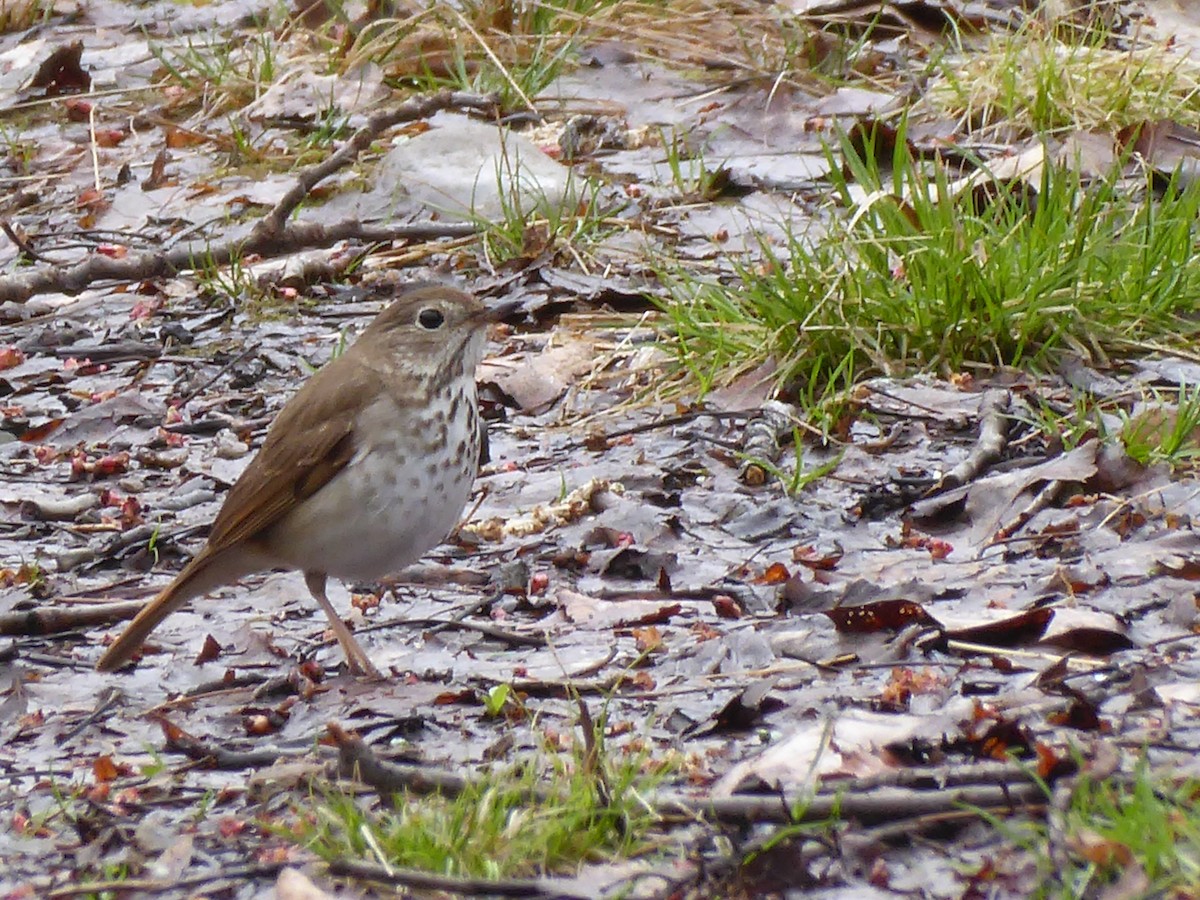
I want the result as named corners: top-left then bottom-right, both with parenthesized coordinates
top-left (661, 124), bottom-right (1200, 396)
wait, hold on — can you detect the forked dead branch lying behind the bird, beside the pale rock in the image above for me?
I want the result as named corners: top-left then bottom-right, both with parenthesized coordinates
top-left (0, 91), bottom-right (496, 304)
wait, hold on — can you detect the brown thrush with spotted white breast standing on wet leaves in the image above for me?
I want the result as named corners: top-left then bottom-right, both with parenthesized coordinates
top-left (88, 284), bottom-right (516, 677)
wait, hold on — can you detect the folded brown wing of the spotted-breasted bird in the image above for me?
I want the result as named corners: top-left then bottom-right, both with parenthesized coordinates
top-left (209, 356), bottom-right (380, 552)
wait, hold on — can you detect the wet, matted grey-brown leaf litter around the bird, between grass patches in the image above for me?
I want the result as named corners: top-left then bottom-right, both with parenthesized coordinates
top-left (0, 2), bottom-right (1200, 898)
